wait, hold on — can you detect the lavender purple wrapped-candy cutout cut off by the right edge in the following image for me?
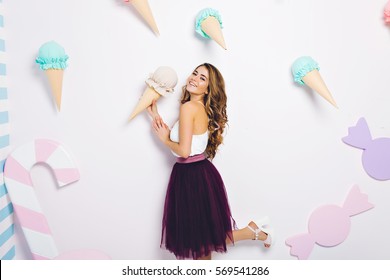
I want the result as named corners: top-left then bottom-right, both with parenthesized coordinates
top-left (342, 118), bottom-right (390, 180)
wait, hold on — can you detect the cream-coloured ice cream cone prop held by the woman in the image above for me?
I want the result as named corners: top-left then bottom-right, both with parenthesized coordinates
top-left (129, 66), bottom-right (178, 121)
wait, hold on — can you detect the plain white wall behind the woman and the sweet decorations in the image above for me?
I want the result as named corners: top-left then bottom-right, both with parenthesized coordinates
top-left (5, 0), bottom-right (390, 259)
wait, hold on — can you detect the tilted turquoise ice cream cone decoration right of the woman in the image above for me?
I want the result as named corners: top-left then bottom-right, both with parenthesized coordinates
top-left (291, 56), bottom-right (337, 108)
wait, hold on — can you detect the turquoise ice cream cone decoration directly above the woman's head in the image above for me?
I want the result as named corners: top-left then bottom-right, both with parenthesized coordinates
top-left (195, 8), bottom-right (226, 50)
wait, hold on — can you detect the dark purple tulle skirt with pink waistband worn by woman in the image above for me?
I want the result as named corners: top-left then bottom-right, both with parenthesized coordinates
top-left (161, 155), bottom-right (235, 259)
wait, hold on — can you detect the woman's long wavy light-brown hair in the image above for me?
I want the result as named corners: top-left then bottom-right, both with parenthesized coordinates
top-left (180, 63), bottom-right (228, 159)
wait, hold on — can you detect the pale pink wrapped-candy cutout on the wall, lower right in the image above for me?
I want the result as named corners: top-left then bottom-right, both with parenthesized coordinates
top-left (286, 185), bottom-right (374, 260)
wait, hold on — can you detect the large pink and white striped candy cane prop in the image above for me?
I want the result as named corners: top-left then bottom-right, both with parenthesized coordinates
top-left (4, 139), bottom-right (80, 260)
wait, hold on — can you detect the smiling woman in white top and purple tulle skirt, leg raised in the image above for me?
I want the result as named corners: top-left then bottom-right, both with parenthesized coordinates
top-left (148, 63), bottom-right (271, 259)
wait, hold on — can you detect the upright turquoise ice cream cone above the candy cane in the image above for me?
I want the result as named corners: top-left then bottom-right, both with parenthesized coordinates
top-left (35, 41), bottom-right (69, 111)
